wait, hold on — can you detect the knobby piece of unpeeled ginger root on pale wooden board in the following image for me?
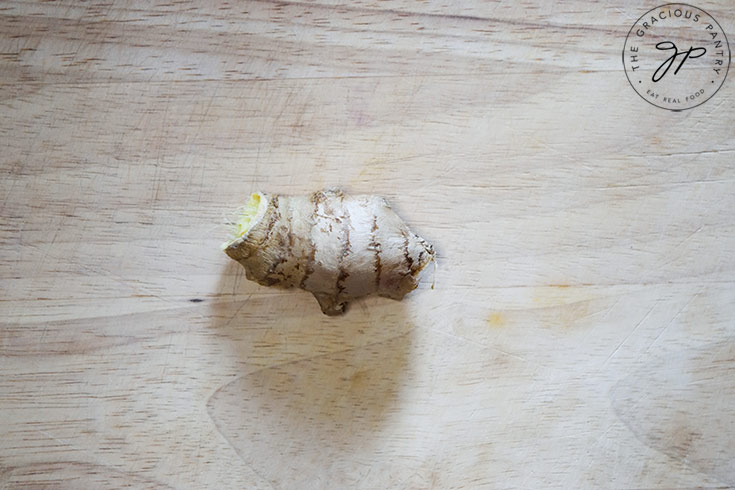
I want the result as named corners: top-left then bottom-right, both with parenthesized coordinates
top-left (223, 189), bottom-right (434, 315)
